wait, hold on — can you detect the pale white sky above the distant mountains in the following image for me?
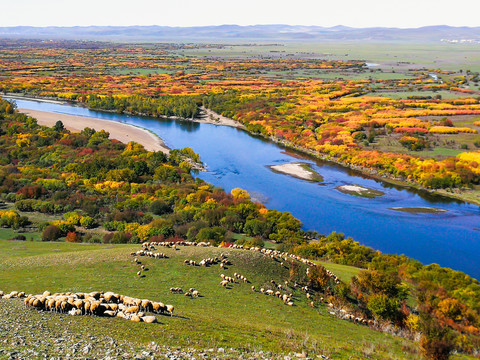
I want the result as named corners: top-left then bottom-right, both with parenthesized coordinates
top-left (0, 0), bottom-right (480, 28)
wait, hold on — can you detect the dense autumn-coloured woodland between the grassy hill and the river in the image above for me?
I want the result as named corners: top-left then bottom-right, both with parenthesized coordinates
top-left (0, 97), bottom-right (480, 359)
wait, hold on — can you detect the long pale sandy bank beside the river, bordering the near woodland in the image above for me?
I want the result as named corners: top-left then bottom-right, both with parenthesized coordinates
top-left (18, 109), bottom-right (170, 154)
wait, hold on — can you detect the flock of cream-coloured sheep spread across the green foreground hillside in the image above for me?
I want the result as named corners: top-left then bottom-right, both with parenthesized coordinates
top-left (0, 241), bottom-right (374, 325)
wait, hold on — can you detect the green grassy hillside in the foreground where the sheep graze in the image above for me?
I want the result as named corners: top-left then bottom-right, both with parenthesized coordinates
top-left (0, 240), bottom-right (464, 359)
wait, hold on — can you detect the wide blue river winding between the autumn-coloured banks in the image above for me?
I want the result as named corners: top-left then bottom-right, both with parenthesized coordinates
top-left (8, 100), bottom-right (480, 279)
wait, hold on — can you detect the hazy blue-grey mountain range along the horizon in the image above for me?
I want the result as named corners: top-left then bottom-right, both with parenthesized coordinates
top-left (0, 25), bottom-right (480, 42)
